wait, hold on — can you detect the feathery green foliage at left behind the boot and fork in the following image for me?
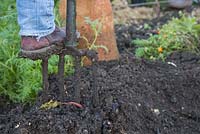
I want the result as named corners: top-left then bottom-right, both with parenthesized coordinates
top-left (0, 0), bottom-right (74, 102)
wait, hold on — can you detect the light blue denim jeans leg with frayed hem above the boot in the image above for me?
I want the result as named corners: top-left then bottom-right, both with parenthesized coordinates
top-left (17, 0), bottom-right (55, 38)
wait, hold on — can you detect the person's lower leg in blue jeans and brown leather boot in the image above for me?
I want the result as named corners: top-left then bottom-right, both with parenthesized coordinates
top-left (17, 0), bottom-right (66, 51)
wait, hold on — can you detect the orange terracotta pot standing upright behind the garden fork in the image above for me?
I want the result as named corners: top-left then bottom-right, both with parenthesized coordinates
top-left (59, 0), bottom-right (119, 64)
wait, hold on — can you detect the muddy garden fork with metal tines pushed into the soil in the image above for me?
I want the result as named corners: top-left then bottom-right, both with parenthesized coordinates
top-left (19, 0), bottom-right (97, 103)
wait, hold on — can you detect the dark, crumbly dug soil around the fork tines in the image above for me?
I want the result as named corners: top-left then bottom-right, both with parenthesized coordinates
top-left (0, 8), bottom-right (200, 134)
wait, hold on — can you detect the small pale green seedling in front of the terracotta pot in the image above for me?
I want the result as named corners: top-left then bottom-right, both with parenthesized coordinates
top-left (80, 17), bottom-right (108, 65)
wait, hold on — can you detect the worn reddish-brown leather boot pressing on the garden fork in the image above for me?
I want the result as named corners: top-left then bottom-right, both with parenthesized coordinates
top-left (21, 27), bottom-right (66, 51)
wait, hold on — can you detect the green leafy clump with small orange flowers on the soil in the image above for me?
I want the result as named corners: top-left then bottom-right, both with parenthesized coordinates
top-left (132, 13), bottom-right (200, 60)
